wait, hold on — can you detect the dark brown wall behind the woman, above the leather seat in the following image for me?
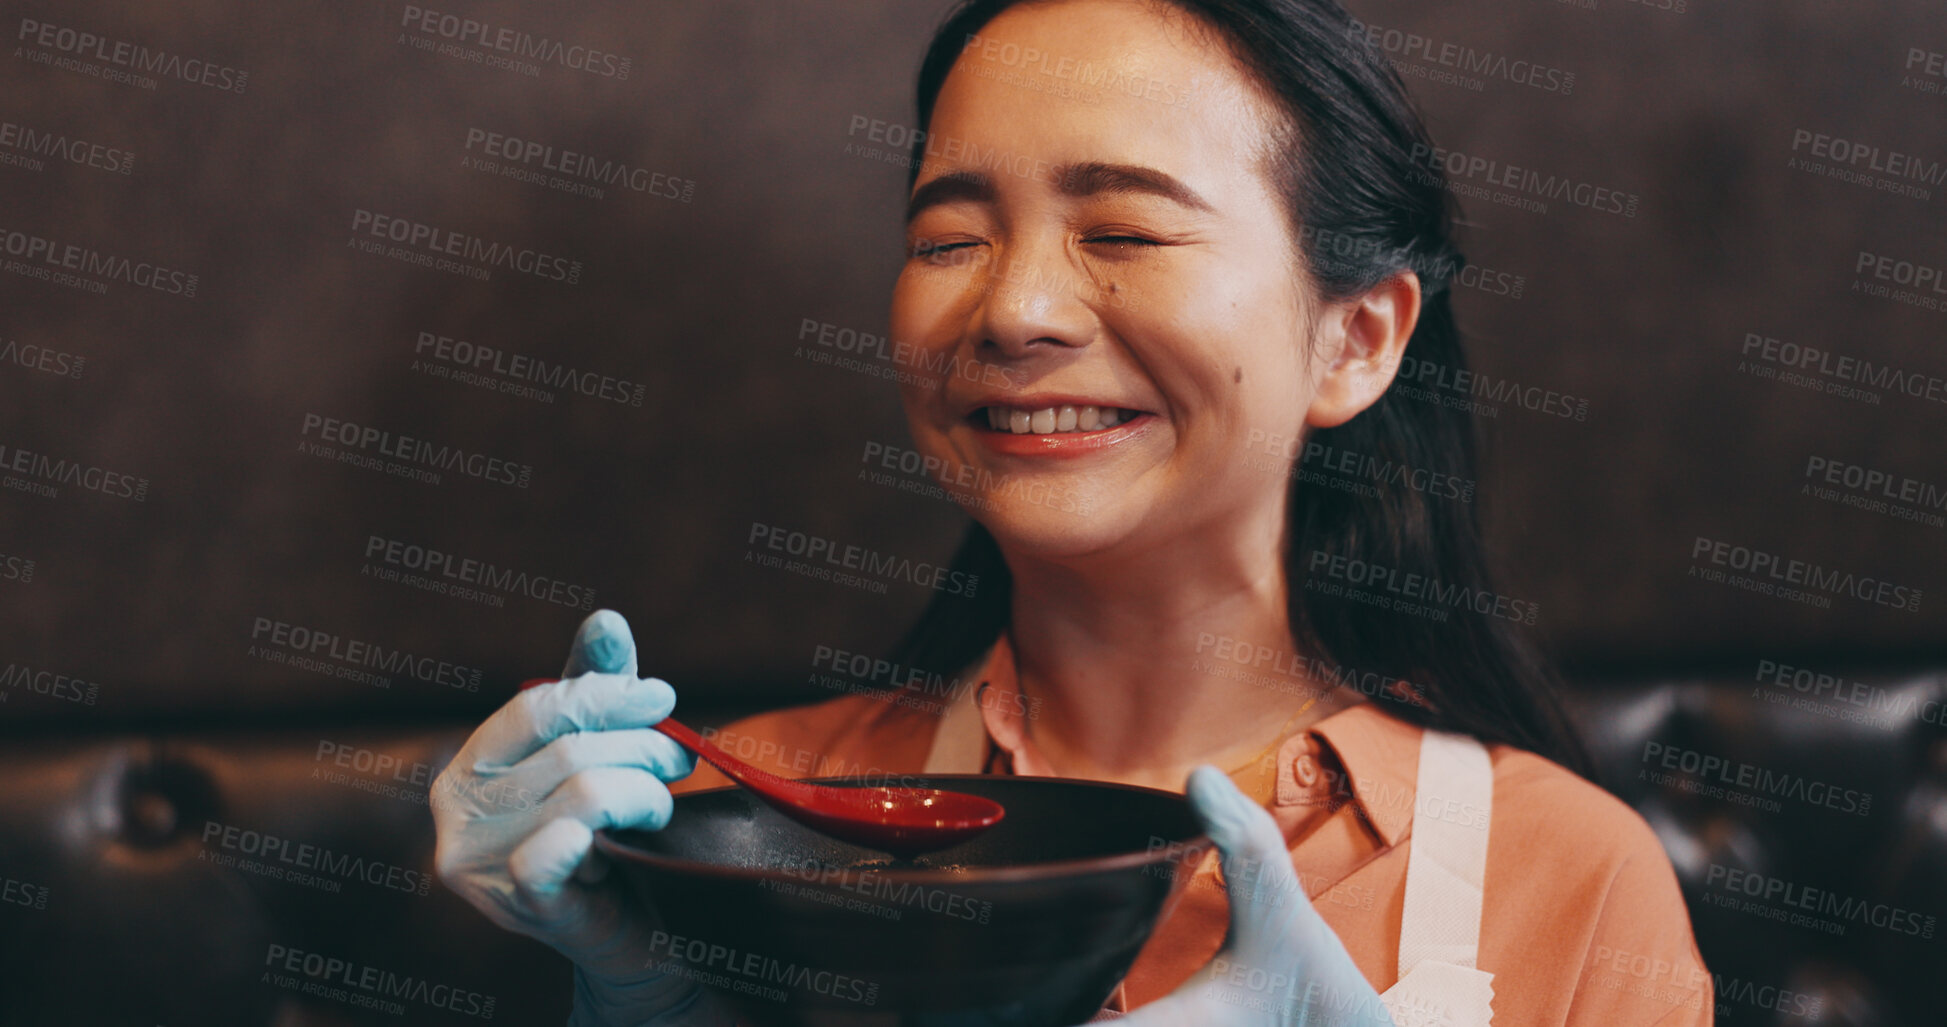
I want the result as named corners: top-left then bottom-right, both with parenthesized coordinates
top-left (0, 0), bottom-right (1947, 723)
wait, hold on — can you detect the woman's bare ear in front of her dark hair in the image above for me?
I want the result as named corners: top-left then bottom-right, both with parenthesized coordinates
top-left (1304, 271), bottom-right (1419, 429)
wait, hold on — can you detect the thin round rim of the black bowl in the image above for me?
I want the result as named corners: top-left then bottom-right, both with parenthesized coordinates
top-left (594, 774), bottom-right (1215, 887)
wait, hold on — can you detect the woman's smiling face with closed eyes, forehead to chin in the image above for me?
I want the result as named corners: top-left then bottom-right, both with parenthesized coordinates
top-left (892, 0), bottom-right (1390, 557)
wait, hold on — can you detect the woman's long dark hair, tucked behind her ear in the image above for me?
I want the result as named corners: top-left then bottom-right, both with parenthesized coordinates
top-left (898, 0), bottom-right (1593, 778)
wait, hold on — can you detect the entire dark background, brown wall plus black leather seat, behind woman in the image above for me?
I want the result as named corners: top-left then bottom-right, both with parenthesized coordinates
top-left (0, 0), bottom-right (1947, 1027)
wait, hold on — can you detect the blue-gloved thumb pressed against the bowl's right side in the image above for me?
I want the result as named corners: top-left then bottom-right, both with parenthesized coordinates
top-left (1188, 766), bottom-right (1318, 961)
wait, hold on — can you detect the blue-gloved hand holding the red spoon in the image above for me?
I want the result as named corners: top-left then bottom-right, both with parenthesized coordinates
top-left (430, 610), bottom-right (730, 1027)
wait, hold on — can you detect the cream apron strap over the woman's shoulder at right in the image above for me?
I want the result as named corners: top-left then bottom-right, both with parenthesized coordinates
top-left (1378, 731), bottom-right (1493, 1027)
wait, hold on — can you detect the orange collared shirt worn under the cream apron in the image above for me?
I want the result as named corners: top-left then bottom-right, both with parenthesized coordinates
top-left (672, 635), bottom-right (1713, 1027)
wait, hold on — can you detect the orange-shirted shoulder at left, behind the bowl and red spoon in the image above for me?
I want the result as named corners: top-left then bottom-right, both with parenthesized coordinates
top-left (670, 692), bottom-right (938, 793)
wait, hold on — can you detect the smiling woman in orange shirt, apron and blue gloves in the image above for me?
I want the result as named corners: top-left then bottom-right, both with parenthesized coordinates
top-left (434, 0), bottom-right (1713, 1027)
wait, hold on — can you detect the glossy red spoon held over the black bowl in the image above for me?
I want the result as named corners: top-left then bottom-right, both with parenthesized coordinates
top-left (522, 678), bottom-right (1007, 859)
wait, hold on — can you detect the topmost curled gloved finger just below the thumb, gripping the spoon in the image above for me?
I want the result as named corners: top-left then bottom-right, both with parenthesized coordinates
top-left (454, 672), bottom-right (676, 774)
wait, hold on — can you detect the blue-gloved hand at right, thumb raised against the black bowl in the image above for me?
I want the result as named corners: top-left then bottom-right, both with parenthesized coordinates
top-left (1116, 766), bottom-right (1394, 1027)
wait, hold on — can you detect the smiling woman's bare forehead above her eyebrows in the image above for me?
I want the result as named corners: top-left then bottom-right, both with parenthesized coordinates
top-left (919, 0), bottom-right (1275, 199)
